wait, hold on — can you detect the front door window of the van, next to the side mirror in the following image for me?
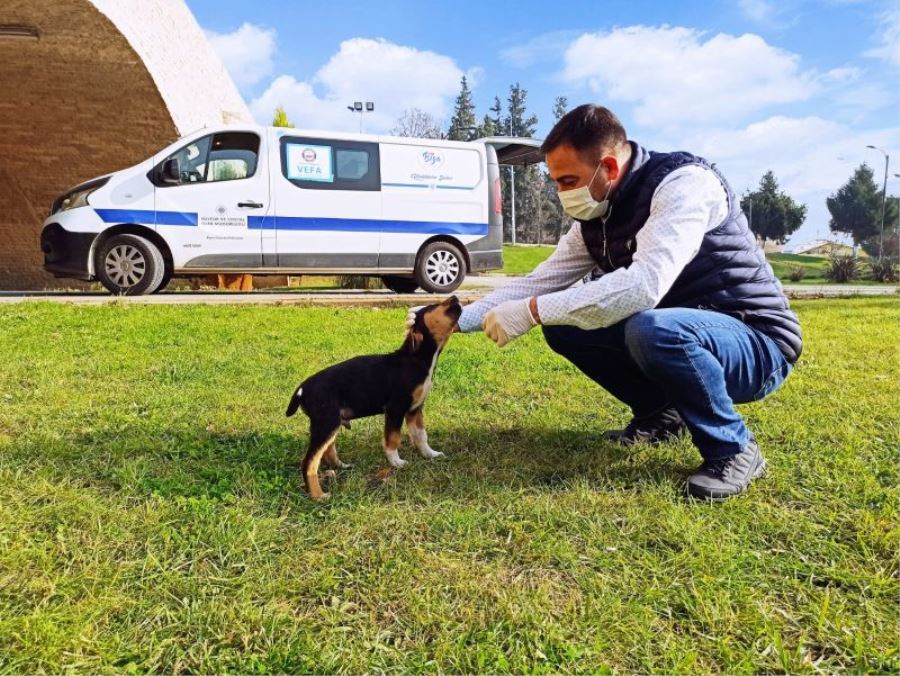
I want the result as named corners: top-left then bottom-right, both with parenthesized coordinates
top-left (152, 132), bottom-right (259, 187)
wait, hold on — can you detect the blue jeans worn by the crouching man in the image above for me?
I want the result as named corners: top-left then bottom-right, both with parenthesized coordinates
top-left (543, 308), bottom-right (792, 460)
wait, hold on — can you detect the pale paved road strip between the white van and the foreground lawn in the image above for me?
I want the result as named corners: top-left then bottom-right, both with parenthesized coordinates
top-left (0, 275), bottom-right (900, 307)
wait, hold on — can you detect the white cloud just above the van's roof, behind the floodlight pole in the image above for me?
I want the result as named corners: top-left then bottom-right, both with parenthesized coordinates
top-left (250, 38), bottom-right (468, 132)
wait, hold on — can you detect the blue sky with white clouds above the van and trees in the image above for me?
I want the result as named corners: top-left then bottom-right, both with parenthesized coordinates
top-left (187, 0), bottom-right (900, 248)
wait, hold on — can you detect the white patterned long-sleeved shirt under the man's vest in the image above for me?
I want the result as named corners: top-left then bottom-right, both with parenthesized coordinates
top-left (459, 165), bottom-right (728, 332)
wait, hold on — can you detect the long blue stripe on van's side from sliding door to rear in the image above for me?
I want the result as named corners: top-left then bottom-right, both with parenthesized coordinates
top-left (247, 216), bottom-right (488, 236)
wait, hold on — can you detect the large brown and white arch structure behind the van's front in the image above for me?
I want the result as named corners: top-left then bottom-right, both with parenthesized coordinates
top-left (0, 0), bottom-right (252, 290)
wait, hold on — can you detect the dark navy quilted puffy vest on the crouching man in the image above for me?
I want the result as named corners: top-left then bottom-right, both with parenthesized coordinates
top-left (581, 143), bottom-right (803, 363)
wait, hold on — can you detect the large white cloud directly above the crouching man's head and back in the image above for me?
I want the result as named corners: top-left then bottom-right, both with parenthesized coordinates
top-left (563, 26), bottom-right (820, 127)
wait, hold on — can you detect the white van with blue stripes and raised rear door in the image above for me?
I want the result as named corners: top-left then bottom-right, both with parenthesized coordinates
top-left (41, 125), bottom-right (541, 295)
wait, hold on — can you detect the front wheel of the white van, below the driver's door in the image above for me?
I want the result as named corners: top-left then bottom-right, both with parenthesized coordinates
top-left (94, 235), bottom-right (166, 296)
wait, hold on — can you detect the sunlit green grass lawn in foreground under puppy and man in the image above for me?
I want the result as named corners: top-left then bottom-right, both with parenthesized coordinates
top-left (0, 299), bottom-right (900, 673)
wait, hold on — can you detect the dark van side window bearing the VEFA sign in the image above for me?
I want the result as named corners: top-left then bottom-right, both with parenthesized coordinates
top-left (281, 136), bottom-right (381, 190)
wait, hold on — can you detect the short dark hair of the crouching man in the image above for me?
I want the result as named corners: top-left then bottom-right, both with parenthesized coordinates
top-left (541, 103), bottom-right (628, 161)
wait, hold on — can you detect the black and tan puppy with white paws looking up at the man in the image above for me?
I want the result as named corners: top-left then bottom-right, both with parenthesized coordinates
top-left (286, 296), bottom-right (462, 500)
